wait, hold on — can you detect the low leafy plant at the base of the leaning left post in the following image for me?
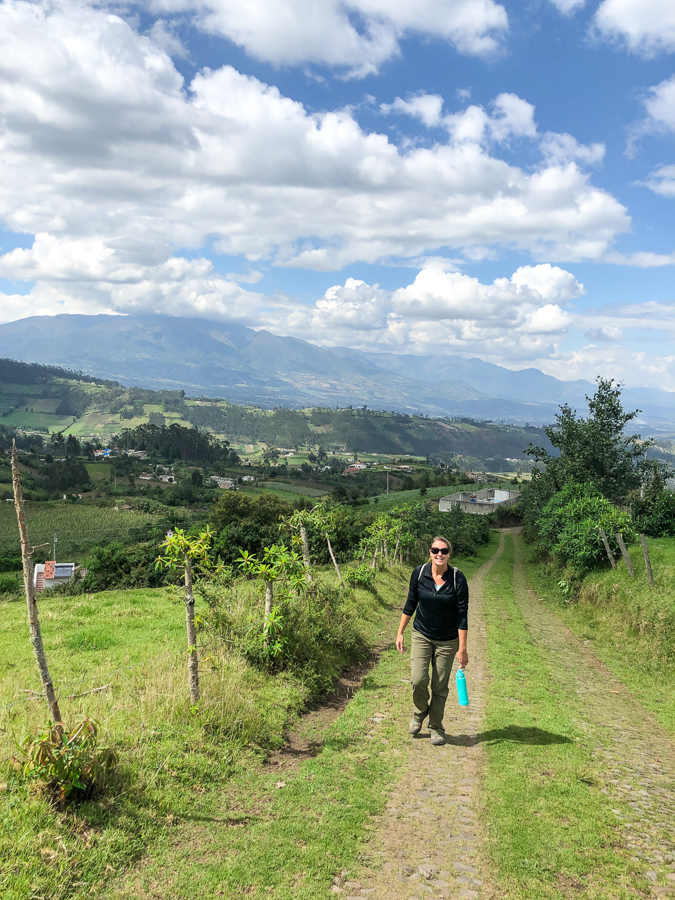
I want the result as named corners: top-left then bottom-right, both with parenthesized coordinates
top-left (12, 718), bottom-right (117, 802)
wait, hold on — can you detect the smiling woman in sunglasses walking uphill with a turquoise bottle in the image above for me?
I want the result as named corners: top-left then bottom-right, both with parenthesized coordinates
top-left (396, 535), bottom-right (469, 746)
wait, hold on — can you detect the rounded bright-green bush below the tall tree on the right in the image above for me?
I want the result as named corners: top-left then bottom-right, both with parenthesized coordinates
top-left (537, 483), bottom-right (636, 570)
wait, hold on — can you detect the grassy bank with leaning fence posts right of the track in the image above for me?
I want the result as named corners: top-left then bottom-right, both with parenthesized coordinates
top-left (528, 538), bottom-right (675, 733)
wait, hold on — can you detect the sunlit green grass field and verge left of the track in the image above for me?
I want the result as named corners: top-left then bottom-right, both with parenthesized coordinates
top-left (0, 544), bottom-right (494, 900)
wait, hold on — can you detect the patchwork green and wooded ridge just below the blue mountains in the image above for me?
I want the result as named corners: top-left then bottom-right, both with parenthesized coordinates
top-left (0, 360), bottom-right (546, 468)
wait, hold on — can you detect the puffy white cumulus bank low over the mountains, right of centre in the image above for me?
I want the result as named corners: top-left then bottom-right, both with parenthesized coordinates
top-left (266, 264), bottom-right (584, 359)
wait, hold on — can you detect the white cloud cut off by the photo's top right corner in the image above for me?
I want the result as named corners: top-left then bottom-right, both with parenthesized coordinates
top-left (595, 0), bottom-right (675, 56)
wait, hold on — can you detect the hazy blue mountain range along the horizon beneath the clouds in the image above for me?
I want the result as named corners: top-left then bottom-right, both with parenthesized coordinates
top-left (0, 315), bottom-right (675, 430)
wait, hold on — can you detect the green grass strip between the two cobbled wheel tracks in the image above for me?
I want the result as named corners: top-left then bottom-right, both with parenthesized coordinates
top-left (484, 536), bottom-right (634, 900)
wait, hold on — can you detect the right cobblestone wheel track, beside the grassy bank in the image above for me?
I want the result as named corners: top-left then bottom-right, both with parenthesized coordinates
top-left (514, 537), bottom-right (675, 897)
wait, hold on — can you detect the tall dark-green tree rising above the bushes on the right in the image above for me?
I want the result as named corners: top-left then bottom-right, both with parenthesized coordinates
top-left (525, 376), bottom-right (653, 500)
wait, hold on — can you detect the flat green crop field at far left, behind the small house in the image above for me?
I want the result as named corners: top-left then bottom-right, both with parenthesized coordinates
top-left (0, 501), bottom-right (162, 562)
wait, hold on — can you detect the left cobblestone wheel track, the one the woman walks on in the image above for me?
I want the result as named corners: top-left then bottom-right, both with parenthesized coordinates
top-left (332, 534), bottom-right (504, 900)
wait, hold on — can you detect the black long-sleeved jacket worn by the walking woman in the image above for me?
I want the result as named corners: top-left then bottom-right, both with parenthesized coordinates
top-left (403, 562), bottom-right (469, 641)
